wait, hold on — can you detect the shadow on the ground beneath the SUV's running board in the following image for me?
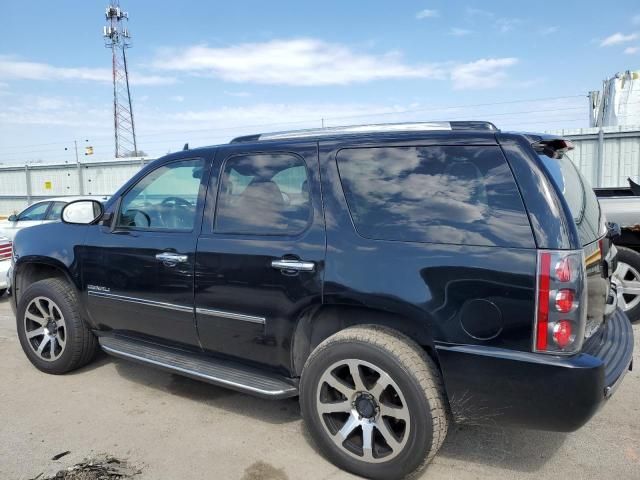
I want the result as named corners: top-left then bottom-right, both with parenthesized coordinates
top-left (111, 357), bottom-right (300, 424)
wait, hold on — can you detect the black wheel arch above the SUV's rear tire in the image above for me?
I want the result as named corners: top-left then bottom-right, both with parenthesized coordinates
top-left (291, 305), bottom-right (439, 376)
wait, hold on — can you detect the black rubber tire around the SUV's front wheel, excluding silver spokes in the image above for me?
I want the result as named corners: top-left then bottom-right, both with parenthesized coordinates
top-left (16, 279), bottom-right (98, 375)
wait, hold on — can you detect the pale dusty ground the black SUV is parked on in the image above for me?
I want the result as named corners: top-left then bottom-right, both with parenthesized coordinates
top-left (0, 292), bottom-right (640, 480)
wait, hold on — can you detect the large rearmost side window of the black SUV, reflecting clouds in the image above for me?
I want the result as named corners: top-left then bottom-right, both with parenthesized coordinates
top-left (337, 146), bottom-right (534, 248)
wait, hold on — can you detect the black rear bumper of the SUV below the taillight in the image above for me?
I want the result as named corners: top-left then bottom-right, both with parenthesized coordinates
top-left (436, 310), bottom-right (633, 432)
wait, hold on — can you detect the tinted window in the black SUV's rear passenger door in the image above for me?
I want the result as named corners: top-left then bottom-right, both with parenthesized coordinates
top-left (214, 154), bottom-right (311, 235)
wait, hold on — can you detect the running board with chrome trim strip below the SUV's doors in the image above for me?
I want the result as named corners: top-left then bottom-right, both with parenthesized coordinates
top-left (98, 336), bottom-right (298, 399)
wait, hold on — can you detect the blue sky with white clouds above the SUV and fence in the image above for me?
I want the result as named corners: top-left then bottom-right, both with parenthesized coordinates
top-left (0, 0), bottom-right (640, 164)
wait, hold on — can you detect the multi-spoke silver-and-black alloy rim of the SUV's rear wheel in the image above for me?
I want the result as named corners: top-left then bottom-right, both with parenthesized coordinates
top-left (316, 359), bottom-right (410, 463)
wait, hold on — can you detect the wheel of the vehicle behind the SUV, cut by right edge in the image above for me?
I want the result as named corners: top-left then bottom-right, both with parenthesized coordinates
top-left (613, 247), bottom-right (640, 322)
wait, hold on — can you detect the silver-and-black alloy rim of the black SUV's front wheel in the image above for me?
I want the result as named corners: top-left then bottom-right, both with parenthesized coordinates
top-left (24, 297), bottom-right (67, 362)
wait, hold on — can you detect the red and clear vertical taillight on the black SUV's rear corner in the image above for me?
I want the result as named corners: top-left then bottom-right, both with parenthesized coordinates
top-left (533, 250), bottom-right (587, 354)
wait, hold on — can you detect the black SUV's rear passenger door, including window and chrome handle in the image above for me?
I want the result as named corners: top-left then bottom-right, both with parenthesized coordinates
top-left (195, 143), bottom-right (325, 370)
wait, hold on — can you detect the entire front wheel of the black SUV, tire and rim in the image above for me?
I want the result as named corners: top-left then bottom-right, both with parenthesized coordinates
top-left (16, 279), bottom-right (98, 374)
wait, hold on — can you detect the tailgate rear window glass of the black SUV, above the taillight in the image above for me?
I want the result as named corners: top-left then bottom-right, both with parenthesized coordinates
top-left (540, 155), bottom-right (601, 245)
